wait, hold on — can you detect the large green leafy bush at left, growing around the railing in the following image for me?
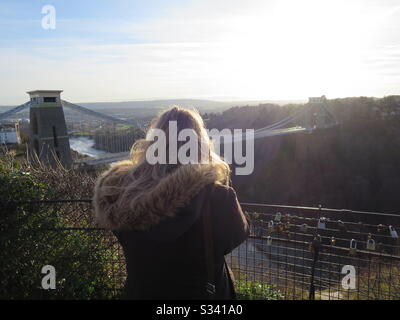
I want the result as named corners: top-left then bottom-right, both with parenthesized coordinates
top-left (0, 161), bottom-right (123, 299)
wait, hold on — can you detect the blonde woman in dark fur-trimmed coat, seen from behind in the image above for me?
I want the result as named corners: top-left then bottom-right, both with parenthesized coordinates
top-left (93, 107), bottom-right (249, 299)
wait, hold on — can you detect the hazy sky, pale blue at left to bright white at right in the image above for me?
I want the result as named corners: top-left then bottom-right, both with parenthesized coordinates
top-left (0, 0), bottom-right (400, 105)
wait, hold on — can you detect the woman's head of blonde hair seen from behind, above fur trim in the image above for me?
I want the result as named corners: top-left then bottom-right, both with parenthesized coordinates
top-left (131, 106), bottom-right (230, 181)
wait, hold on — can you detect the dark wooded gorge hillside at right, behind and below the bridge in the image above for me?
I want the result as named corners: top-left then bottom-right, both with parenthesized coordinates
top-left (208, 98), bottom-right (400, 212)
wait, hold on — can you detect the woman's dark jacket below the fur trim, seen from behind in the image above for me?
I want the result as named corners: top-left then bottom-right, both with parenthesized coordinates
top-left (95, 162), bottom-right (249, 299)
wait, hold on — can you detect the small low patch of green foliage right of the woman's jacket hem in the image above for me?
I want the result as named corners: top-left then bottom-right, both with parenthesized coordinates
top-left (236, 280), bottom-right (284, 300)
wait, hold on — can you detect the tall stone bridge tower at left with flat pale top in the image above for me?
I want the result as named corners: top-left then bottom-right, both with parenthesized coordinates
top-left (28, 90), bottom-right (72, 168)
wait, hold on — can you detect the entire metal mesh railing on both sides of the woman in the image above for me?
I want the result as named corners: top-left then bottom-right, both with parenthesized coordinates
top-left (1, 199), bottom-right (400, 300)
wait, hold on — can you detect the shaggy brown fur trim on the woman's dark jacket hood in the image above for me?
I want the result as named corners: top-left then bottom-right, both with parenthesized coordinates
top-left (93, 161), bottom-right (222, 231)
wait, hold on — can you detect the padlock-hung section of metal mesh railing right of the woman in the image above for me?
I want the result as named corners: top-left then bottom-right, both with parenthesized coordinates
top-left (229, 203), bottom-right (400, 300)
